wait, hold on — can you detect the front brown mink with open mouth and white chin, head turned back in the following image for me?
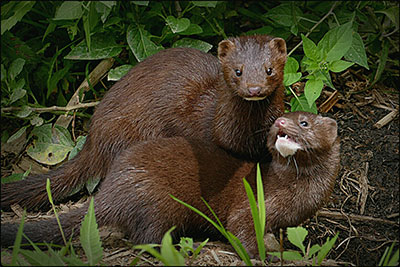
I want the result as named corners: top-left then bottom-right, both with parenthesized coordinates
top-left (1, 112), bottom-right (340, 255)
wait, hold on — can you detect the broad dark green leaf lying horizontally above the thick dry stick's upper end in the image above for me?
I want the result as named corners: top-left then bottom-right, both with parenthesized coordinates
top-left (64, 34), bottom-right (122, 60)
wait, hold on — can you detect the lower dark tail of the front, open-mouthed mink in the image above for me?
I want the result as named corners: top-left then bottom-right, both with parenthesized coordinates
top-left (1, 205), bottom-right (87, 247)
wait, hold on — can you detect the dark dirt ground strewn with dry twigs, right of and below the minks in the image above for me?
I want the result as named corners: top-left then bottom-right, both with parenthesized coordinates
top-left (1, 72), bottom-right (399, 266)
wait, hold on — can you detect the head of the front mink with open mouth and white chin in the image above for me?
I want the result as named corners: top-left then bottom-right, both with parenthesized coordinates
top-left (268, 111), bottom-right (337, 159)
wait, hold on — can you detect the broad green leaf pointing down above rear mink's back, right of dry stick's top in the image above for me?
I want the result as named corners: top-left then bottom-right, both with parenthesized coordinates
top-left (126, 25), bottom-right (164, 62)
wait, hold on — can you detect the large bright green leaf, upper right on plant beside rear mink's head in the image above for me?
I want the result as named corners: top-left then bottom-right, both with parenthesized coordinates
top-left (317, 22), bottom-right (353, 62)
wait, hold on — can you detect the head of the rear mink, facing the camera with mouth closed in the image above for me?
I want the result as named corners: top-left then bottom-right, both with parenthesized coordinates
top-left (218, 35), bottom-right (286, 100)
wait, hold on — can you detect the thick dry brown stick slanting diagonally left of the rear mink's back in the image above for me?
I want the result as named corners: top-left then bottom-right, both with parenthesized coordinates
top-left (55, 58), bottom-right (114, 128)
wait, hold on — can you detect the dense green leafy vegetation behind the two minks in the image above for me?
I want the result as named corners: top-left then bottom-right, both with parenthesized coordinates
top-left (1, 1), bottom-right (399, 266)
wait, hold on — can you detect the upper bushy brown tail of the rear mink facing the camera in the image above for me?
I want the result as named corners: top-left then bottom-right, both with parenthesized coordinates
top-left (1, 138), bottom-right (111, 213)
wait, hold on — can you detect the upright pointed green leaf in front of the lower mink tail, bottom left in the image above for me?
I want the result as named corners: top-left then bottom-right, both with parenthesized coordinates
top-left (80, 197), bottom-right (103, 266)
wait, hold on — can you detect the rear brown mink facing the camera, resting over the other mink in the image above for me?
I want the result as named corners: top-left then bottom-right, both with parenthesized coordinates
top-left (1, 35), bottom-right (286, 209)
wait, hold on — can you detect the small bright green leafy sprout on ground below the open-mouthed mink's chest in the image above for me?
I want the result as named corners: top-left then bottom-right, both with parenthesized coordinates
top-left (268, 226), bottom-right (339, 266)
